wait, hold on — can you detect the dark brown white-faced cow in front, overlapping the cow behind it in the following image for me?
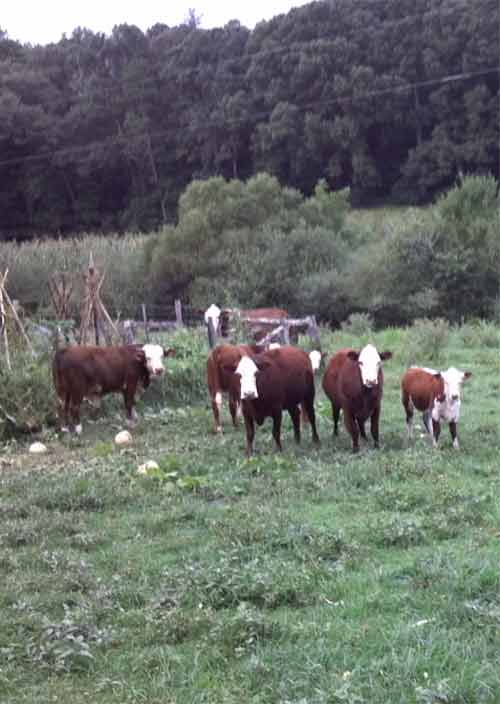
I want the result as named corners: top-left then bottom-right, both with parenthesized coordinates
top-left (226, 346), bottom-right (319, 457)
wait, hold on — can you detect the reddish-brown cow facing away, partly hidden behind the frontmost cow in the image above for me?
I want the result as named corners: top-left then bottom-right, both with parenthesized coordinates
top-left (207, 345), bottom-right (262, 433)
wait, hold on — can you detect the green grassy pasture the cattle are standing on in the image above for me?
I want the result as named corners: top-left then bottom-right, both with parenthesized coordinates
top-left (0, 329), bottom-right (500, 704)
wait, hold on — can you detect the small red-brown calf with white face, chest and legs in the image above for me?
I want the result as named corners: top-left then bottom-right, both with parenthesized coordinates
top-left (401, 367), bottom-right (472, 450)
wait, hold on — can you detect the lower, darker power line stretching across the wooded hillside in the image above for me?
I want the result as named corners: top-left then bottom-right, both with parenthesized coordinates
top-left (0, 66), bottom-right (494, 166)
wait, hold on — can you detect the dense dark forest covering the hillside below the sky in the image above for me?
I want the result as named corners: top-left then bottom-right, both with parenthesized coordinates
top-left (0, 0), bottom-right (499, 239)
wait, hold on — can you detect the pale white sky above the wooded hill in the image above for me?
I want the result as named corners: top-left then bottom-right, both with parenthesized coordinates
top-left (0, 0), bottom-right (306, 44)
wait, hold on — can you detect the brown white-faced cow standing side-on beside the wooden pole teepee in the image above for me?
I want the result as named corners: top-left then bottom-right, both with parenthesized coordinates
top-left (52, 344), bottom-right (175, 435)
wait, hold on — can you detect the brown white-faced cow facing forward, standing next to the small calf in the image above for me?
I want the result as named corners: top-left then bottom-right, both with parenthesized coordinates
top-left (323, 345), bottom-right (392, 452)
